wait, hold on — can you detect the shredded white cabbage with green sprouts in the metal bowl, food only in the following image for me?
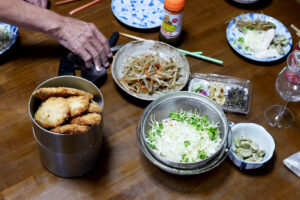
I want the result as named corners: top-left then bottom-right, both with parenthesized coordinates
top-left (146, 111), bottom-right (221, 163)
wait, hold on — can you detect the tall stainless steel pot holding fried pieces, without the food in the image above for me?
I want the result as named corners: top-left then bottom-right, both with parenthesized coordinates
top-left (28, 76), bottom-right (104, 177)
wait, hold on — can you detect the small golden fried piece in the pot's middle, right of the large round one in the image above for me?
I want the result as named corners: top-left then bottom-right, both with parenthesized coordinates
top-left (67, 96), bottom-right (89, 117)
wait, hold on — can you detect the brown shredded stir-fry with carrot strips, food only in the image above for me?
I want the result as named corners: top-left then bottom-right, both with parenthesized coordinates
top-left (119, 53), bottom-right (184, 95)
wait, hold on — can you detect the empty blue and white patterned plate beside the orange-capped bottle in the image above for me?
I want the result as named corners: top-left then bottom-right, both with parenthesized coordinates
top-left (111, 0), bottom-right (164, 29)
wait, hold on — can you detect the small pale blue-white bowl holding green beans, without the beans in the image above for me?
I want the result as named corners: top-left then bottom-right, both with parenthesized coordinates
top-left (228, 123), bottom-right (275, 170)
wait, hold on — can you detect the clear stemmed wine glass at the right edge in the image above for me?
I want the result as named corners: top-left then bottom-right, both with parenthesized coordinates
top-left (265, 50), bottom-right (300, 128)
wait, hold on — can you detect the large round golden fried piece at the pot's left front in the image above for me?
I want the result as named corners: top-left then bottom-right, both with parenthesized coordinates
top-left (34, 97), bottom-right (70, 128)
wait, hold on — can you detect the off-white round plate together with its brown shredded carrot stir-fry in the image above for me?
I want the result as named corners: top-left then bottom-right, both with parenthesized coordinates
top-left (111, 40), bottom-right (190, 101)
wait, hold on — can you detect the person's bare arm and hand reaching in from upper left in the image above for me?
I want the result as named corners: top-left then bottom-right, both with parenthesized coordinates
top-left (0, 0), bottom-right (112, 70)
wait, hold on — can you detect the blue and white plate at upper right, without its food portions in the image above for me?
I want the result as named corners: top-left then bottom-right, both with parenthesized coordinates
top-left (226, 13), bottom-right (292, 62)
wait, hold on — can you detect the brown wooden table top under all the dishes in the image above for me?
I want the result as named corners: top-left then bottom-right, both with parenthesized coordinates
top-left (0, 0), bottom-right (300, 200)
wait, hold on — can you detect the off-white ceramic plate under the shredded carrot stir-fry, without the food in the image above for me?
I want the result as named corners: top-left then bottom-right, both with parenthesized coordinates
top-left (111, 40), bottom-right (190, 101)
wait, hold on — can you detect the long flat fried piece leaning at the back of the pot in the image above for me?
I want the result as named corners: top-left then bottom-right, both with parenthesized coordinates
top-left (32, 87), bottom-right (94, 101)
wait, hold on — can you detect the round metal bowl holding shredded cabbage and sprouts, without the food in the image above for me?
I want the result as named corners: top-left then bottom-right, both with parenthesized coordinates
top-left (137, 91), bottom-right (231, 170)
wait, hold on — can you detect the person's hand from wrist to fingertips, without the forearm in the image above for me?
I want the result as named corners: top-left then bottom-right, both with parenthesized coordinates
top-left (50, 17), bottom-right (112, 71)
